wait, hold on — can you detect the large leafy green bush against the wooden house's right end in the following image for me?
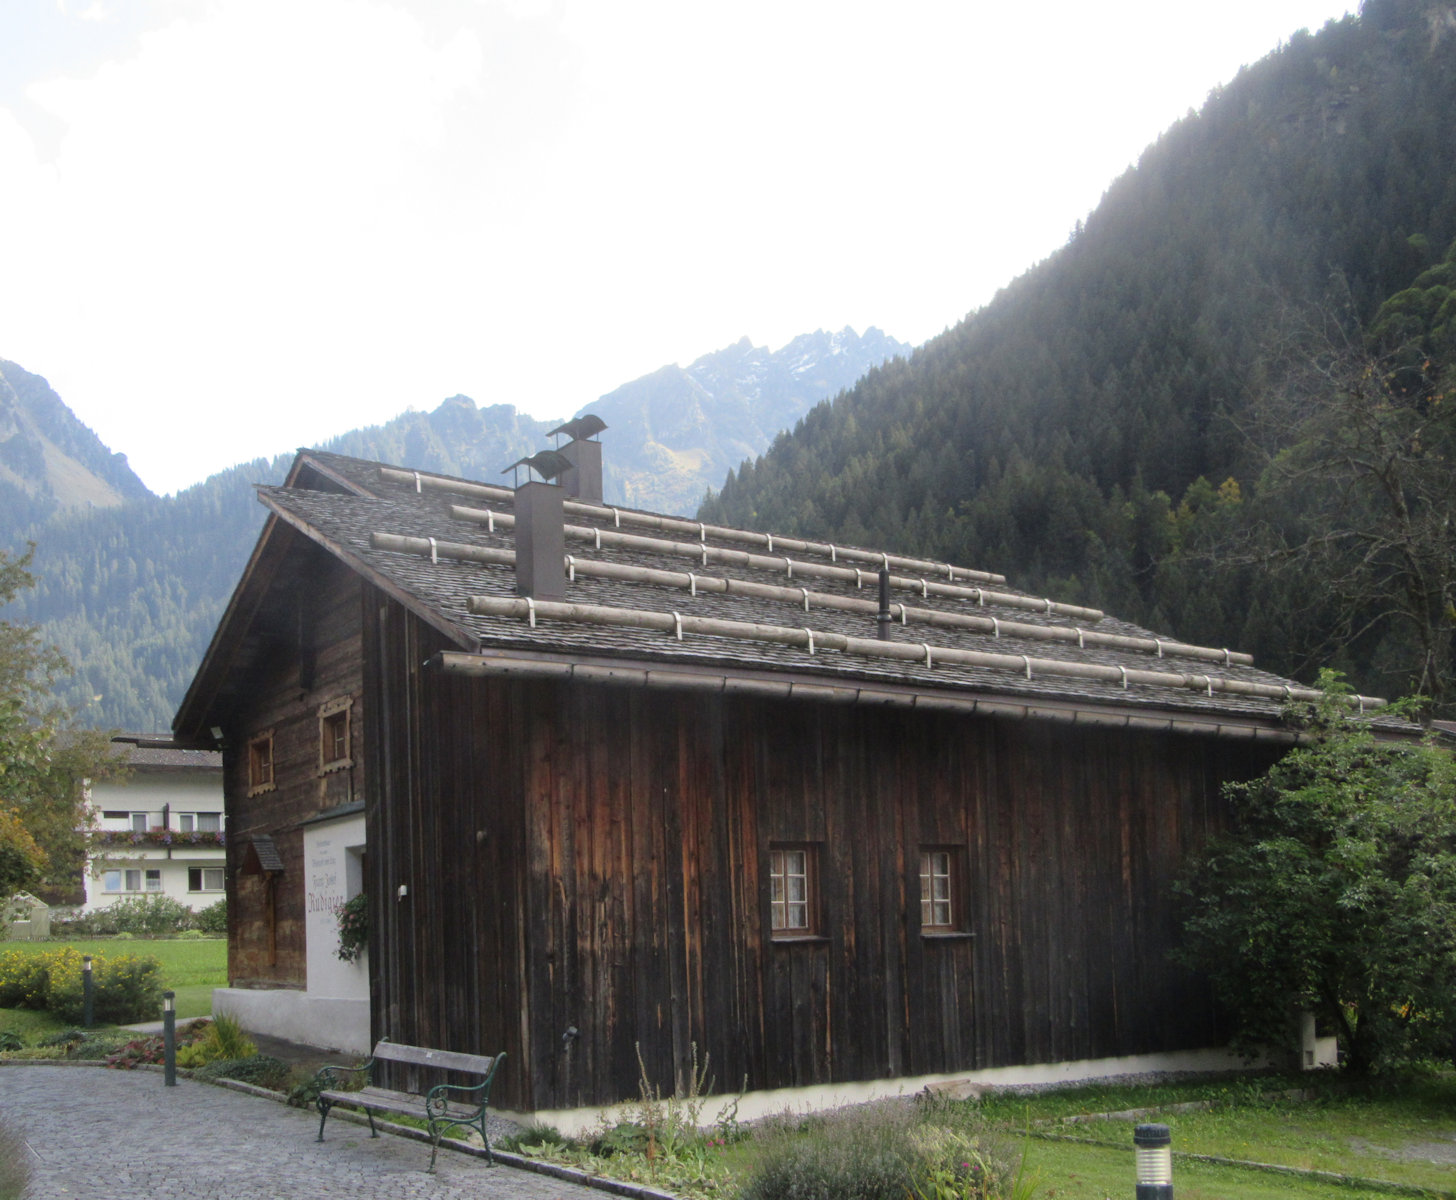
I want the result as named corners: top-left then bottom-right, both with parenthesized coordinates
top-left (1176, 676), bottom-right (1456, 1075)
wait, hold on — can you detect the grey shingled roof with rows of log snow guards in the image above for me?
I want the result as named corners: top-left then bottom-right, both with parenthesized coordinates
top-left (178, 450), bottom-right (1412, 737)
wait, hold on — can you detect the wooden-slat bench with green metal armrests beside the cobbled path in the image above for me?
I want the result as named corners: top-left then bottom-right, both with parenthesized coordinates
top-left (314, 1038), bottom-right (505, 1171)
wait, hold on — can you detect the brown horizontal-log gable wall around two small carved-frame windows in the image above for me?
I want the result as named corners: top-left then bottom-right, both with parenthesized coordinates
top-left (221, 537), bottom-right (364, 987)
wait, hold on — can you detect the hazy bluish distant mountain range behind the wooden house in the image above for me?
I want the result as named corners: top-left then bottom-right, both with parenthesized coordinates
top-left (0, 331), bottom-right (909, 731)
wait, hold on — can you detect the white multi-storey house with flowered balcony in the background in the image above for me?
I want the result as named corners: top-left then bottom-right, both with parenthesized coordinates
top-left (83, 735), bottom-right (227, 912)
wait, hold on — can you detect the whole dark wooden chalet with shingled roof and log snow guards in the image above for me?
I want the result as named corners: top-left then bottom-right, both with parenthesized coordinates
top-left (175, 443), bottom-right (1397, 1111)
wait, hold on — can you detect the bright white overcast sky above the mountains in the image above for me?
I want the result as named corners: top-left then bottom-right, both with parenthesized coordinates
top-left (0, 0), bottom-right (1354, 492)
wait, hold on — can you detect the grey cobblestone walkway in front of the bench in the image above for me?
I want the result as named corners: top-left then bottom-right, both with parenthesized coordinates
top-left (0, 1066), bottom-right (607, 1200)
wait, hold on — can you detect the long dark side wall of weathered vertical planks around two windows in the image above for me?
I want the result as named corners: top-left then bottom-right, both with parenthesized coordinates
top-left (368, 604), bottom-right (1270, 1108)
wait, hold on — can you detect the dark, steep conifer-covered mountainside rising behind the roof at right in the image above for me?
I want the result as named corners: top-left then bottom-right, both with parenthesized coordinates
top-left (699, 0), bottom-right (1456, 713)
